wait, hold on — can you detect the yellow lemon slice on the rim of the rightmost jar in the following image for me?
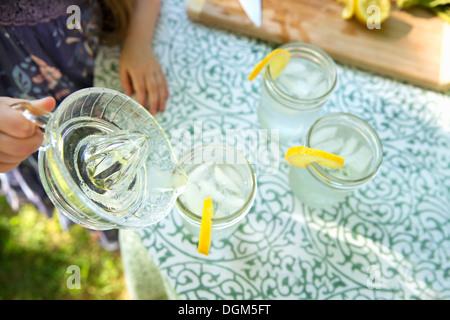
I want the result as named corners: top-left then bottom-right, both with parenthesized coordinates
top-left (285, 146), bottom-right (344, 169)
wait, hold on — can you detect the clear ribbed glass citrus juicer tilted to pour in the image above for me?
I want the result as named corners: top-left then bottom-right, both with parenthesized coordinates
top-left (13, 88), bottom-right (188, 230)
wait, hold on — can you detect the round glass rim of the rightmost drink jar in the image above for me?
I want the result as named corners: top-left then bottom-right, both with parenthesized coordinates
top-left (305, 112), bottom-right (383, 189)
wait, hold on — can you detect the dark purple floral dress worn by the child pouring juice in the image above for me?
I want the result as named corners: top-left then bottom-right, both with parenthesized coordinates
top-left (0, 0), bottom-right (101, 225)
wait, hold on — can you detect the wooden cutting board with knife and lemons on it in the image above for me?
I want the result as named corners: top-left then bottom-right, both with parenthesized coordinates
top-left (186, 0), bottom-right (450, 91)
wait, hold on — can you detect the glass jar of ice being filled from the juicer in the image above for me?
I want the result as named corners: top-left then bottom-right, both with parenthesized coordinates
top-left (176, 144), bottom-right (257, 244)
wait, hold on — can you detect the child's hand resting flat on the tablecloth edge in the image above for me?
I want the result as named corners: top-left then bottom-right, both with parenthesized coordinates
top-left (120, 39), bottom-right (169, 115)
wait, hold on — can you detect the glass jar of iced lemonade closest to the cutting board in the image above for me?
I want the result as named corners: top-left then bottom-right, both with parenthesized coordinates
top-left (258, 42), bottom-right (337, 141)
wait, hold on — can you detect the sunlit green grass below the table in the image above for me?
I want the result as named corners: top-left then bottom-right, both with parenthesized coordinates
top-left (0, 196), bottom-right (128, 300)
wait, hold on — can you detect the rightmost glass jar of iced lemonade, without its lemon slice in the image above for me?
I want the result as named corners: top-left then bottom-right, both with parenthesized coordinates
top-left (289, 113), bottom-right (383, 208)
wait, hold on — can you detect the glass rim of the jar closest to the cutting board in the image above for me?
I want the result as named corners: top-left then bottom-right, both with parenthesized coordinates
top-left (264, 42), bottom-right (337, 109)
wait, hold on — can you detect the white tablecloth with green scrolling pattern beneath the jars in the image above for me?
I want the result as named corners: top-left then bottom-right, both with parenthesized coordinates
top-left (96, 0), bottom-right (450, 299)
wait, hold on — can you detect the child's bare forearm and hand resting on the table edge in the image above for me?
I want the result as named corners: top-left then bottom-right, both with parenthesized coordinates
top-left (120, 0), bottom-right (169, 114)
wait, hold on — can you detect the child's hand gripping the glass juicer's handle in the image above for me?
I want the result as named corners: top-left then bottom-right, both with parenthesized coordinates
top-left (0, 97), bottom-right (55, 172)
